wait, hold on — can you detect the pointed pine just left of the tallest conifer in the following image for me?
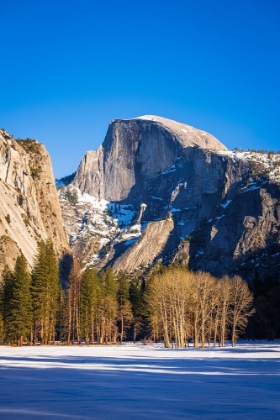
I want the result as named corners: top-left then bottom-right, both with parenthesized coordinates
top-left (5, 253), bottom-right (32, 345)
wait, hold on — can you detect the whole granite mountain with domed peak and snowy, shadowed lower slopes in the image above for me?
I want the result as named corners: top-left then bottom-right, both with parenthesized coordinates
top-left (60, 116), bottom-right (280, 279)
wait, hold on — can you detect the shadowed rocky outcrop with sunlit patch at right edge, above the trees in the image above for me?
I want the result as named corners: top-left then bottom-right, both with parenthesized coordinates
top-left (182, 181), bottom-right (280, 279)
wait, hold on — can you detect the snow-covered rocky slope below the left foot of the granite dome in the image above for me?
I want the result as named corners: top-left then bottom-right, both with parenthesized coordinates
top-left (58, 184), bottom-right (145, 265)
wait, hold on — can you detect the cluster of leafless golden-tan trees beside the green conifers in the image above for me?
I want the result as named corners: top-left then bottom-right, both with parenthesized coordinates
top-left (146, 267), bottom-right (253, 347)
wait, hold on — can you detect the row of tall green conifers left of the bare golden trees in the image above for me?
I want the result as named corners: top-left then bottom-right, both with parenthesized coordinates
top-left (0, 240), bottom-right (140, 345)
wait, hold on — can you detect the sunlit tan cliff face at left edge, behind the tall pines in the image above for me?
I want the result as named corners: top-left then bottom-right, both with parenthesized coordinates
top-left (0, 130), bottom-right (68, 271)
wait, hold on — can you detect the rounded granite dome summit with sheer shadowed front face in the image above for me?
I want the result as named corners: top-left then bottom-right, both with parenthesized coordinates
top-left (74, 116), bottom-right (226, 201)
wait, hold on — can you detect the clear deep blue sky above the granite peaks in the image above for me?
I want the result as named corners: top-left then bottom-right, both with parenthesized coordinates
top-left (0, 0), bottom-right (280, 177)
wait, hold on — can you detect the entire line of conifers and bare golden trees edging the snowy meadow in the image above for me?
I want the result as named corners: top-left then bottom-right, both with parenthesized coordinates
top-left (0, 240), bottom-right (254, 347)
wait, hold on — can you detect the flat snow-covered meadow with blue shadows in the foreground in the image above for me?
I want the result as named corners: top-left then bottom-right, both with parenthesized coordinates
top-left (0, 342), bottom-right (280, 420)
